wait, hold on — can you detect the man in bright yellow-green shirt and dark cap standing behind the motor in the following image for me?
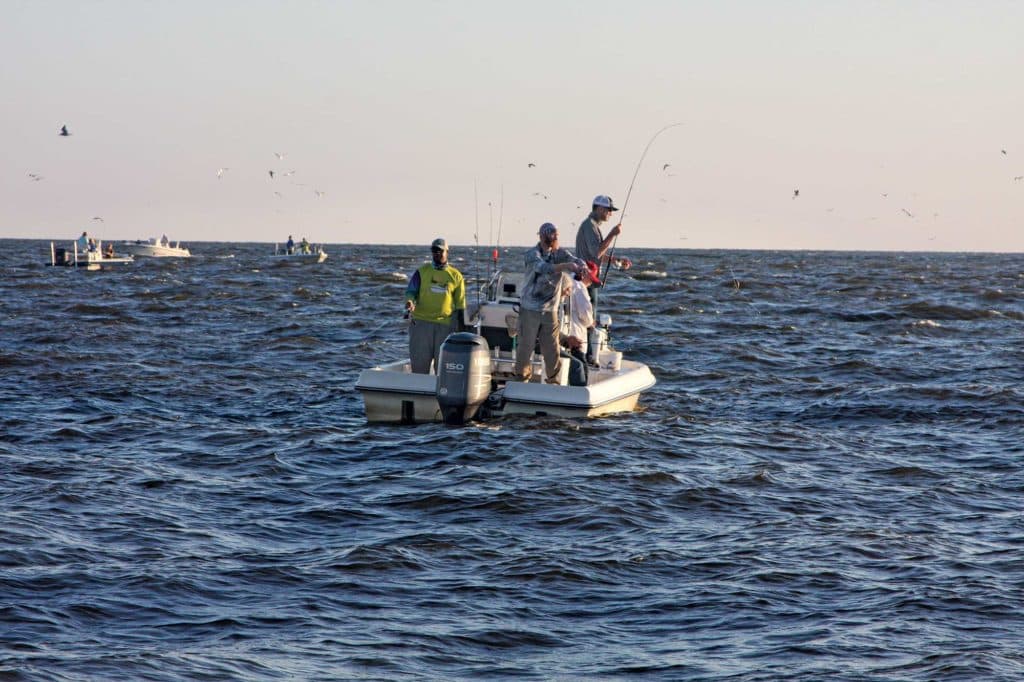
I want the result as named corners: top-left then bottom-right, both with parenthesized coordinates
top-left (406, 238), bottom-right (466, 374)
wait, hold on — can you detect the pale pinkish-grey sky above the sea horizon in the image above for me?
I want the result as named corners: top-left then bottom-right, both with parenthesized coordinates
top-left (0, 0), bottom-right (1024, 252)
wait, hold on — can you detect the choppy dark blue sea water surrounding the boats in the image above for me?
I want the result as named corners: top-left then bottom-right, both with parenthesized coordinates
top-left (0, 240), bottom-right (1024, 680)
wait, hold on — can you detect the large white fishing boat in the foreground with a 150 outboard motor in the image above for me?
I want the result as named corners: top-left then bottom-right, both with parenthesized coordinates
top-left (355, 272), bottom-right (655, 424)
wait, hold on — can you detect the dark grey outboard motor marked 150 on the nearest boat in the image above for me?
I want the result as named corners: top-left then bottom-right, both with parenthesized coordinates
top-left (437, 332), bottom-right (490, 424)
